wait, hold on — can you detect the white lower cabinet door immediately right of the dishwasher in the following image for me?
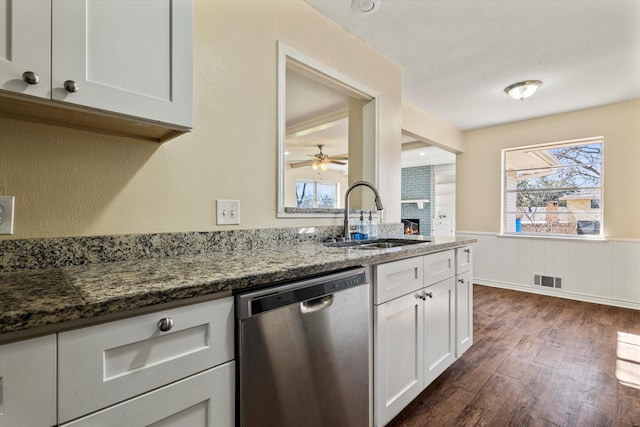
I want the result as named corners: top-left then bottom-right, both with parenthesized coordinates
top-left (373, 290), bottom-right (424, 426)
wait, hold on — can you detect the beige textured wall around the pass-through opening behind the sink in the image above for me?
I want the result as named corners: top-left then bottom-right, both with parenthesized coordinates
top-left (0, 0), bottom-right (401, 239)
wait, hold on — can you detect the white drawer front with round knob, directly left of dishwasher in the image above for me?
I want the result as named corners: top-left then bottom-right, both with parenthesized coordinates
top-left (58, 297), bottom-right (233, 423)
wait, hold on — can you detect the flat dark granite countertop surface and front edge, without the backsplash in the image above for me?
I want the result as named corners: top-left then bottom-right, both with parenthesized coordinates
top-left (0, 237), bottom-right (475, 342)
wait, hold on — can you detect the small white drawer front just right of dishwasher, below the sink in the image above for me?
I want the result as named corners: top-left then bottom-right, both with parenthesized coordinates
top-left (374, 257), bottom-right (424, 304)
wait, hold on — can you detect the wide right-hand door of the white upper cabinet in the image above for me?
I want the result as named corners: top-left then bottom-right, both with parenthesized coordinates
top-left (51, 0), bottom-right (193, 128)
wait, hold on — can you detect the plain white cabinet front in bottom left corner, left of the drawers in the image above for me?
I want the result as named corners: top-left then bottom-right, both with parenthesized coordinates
top-left (0, 335), bottom-right (56, 427)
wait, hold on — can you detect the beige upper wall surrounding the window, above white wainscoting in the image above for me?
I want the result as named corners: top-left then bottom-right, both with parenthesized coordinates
top-left (456, 99), bottom-right (640, 239)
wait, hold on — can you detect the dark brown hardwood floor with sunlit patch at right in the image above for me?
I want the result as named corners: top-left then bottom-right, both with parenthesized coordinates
top-left (388, 285), bottom-right (640, 427)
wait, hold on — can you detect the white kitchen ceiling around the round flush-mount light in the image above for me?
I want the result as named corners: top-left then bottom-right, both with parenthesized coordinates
top-left (306, 0), bottom-right (640, 130)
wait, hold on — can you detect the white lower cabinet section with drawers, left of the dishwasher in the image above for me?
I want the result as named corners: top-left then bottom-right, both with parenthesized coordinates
top-left (0, 297), bottom-right (235, 427)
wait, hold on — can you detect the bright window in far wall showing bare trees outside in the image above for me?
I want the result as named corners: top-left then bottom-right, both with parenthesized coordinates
top-left (502, 138), bottom-right (603, 237)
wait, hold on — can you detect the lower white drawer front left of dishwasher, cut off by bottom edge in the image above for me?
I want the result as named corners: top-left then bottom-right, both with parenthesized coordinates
top-left (61, 362), bottom-right (235, 427)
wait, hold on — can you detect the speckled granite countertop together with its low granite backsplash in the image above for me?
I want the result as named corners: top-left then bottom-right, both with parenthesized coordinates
top-left (0, 224), bottom-right (475, 343)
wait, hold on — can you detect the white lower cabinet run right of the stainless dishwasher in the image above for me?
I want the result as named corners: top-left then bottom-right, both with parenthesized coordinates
top-left (373, 250), bottom-right (473, 427)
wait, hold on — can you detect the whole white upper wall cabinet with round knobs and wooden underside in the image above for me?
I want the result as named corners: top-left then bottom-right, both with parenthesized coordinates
top-left (0, 0), bottom-right (193, 142)
